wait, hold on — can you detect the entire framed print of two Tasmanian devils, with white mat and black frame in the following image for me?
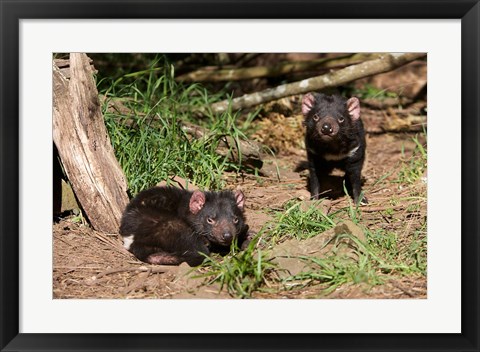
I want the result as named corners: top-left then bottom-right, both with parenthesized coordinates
top-left (0, 0), bottom-right (480, 351)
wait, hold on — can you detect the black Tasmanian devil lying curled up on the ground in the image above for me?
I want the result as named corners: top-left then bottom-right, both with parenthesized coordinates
top-left (120, 187), bottom-right (250, 266)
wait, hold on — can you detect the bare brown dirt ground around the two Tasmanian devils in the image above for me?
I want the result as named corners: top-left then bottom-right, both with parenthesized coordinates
top-left (53, 58), bottom-right (427, 299)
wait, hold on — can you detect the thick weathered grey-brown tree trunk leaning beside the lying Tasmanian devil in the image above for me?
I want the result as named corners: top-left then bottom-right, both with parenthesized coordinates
top-left (53, 53), bottom-right (128, 233)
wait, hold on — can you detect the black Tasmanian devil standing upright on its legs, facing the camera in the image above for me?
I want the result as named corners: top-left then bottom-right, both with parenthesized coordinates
top-left (302, 93), bottom-right (367, 204)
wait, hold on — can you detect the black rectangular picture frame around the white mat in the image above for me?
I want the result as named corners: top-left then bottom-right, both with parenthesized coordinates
top-left (0, 0), bottom-right (480, 351)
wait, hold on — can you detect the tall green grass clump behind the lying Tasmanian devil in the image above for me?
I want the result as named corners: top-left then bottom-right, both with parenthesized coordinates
top-left (99, 56), bottom-right (253, 195)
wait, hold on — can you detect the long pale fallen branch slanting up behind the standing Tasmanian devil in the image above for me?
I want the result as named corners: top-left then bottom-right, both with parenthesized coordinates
top-left (208, 53), bottom-right (426, 115)
